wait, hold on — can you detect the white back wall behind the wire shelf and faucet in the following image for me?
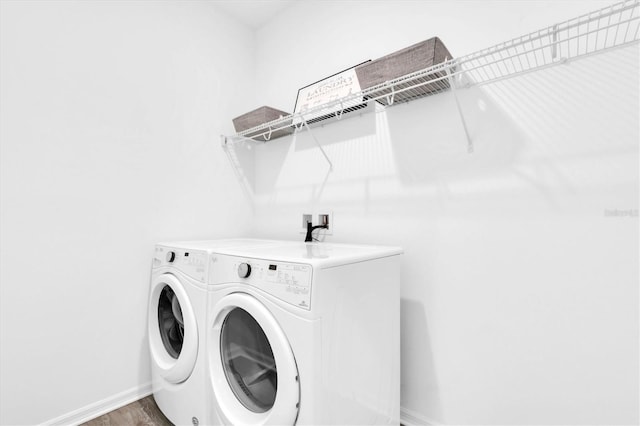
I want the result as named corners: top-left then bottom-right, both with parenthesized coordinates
top-left (238, 1), bottom-right (640, 424)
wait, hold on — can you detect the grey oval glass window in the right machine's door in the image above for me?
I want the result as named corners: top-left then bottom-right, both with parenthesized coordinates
top-left (220, 308), bottom-right (278, 413)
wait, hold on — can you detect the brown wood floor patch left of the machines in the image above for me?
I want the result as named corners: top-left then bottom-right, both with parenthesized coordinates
top-left (81, 396), bottom-right (173, 426)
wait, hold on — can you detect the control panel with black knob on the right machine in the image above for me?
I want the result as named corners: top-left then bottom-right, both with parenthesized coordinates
top-left (234, 259), bottom-right (312, 310)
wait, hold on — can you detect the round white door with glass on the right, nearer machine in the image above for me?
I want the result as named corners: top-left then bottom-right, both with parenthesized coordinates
top-left (209, 293), bottom-right (300, 425)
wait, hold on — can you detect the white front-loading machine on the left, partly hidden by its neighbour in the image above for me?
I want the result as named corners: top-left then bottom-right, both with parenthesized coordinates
top-left (148, 239), bottom-right (282, 425)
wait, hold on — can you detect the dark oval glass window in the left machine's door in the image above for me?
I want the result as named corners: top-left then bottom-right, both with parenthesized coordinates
top-left (158, 285), bottom-right (184, 359)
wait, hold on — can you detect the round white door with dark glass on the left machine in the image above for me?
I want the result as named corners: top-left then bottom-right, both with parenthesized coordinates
top-left (148, 273), bottom-right (198, 383)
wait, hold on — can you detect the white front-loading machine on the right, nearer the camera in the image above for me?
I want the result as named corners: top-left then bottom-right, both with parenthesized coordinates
top-left (206, 242), bottom-right (402, 425)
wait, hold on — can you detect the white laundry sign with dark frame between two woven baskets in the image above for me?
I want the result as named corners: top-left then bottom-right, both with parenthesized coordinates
top-left (293, 61), bottom-right (370, 124)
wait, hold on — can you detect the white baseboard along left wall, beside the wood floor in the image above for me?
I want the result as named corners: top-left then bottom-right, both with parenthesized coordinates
top-left (41, 382), bottom-right (151, 426)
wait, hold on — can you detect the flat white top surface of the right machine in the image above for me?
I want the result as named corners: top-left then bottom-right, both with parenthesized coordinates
top-left (216, 241), bottom-right (403, 268)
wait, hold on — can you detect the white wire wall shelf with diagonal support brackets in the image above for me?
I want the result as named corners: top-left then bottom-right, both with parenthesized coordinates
top-left (222, 0), bottom-right (640, 163)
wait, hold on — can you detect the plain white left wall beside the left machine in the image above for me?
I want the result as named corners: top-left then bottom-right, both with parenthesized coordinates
top-left (0, 1), bottom-right (254, 424)
